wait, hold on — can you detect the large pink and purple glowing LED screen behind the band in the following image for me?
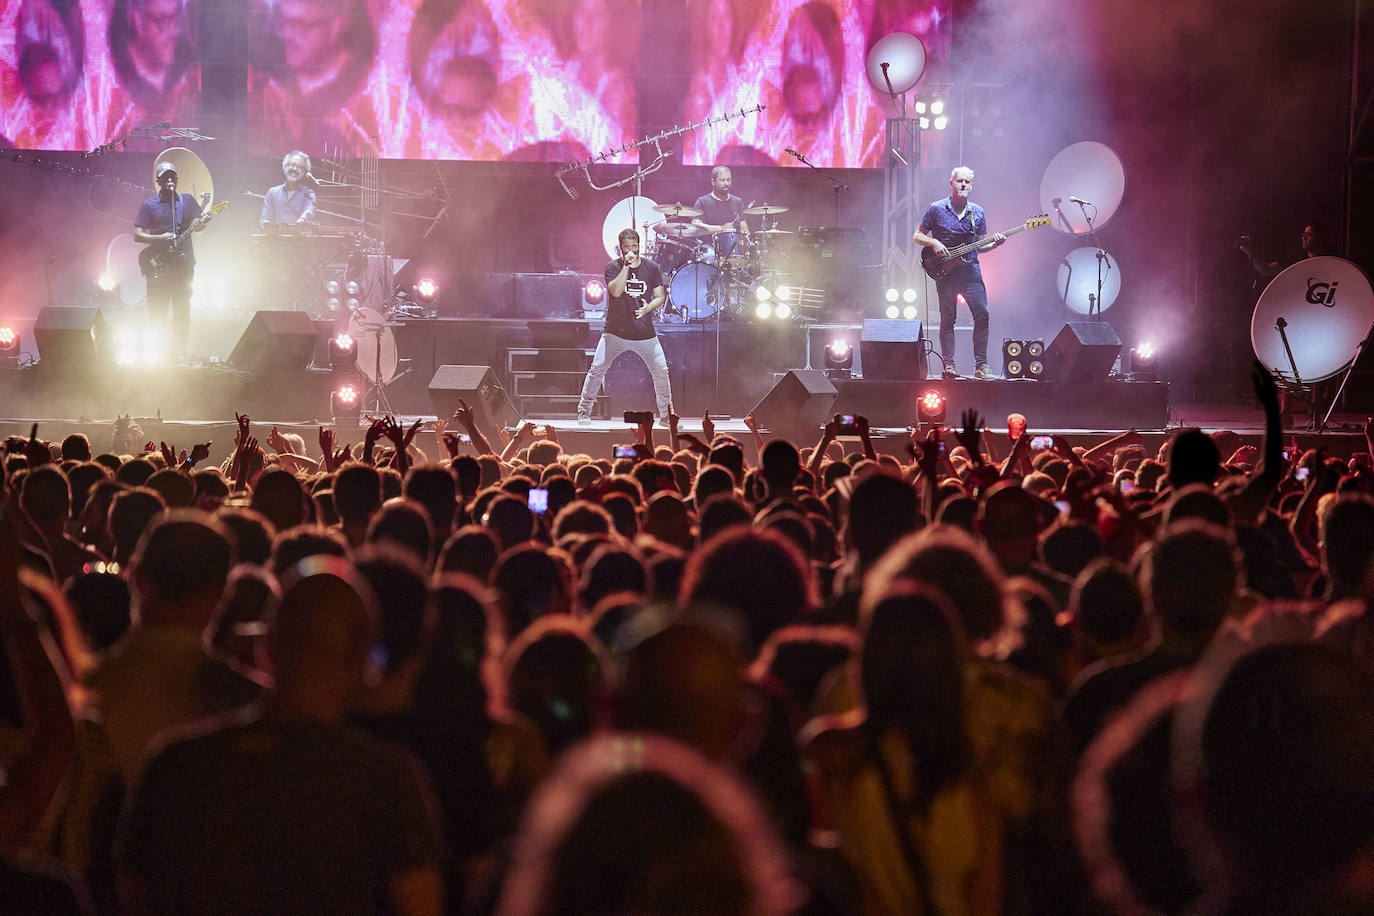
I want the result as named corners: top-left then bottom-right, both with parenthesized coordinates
top-left (0, 0), bottom-right (952, 168)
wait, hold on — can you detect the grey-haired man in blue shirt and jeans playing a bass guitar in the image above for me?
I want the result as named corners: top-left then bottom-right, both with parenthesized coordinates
top-left (911, 165), bottom-right (1007, 379)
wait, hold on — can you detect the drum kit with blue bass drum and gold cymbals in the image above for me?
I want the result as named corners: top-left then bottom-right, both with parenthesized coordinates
top-left (647, 203), bottom-right (791, 321)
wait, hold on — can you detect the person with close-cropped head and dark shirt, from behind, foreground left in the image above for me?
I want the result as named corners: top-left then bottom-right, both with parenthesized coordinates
top-left (118, 556), bottom-right (442, 915)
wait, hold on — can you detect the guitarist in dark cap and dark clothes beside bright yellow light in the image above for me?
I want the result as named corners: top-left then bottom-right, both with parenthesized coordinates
top-left (133, 162), bottom-right (210, 361)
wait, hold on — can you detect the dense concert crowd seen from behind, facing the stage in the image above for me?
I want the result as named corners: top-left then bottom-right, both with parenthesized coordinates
top-left (0, 371), bottom-right (1374, 916)
